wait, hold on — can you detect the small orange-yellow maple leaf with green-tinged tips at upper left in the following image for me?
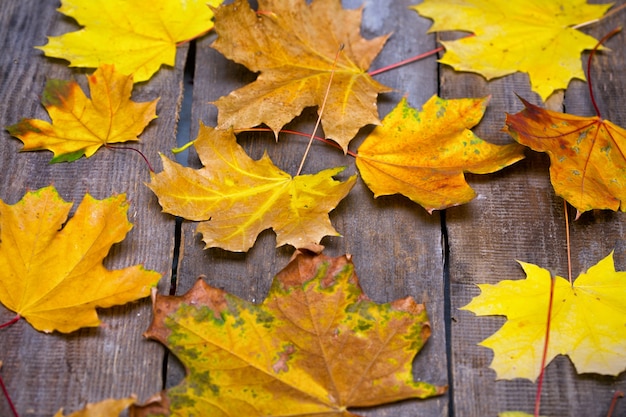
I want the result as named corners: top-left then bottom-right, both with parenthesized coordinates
top-left (7, 65), bottom-right (158, 162)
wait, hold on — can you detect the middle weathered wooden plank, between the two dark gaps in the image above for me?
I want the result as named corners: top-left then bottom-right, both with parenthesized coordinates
top-left (168, 0), bottom-right (448, 417)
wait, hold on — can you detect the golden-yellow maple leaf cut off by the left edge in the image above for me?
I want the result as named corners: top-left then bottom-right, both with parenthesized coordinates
top-left (0, 186), bottom-right (161, 333)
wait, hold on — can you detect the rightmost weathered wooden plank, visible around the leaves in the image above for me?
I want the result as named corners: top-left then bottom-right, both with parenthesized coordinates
top-left (441, 1), bottom-right (626, 416)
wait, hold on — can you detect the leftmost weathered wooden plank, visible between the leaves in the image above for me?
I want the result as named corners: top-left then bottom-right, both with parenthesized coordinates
top-left (0, 0), bottom-right (185, 417)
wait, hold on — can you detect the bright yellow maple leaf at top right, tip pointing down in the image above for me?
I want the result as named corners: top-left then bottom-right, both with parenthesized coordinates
top-left (412, 0), bottom-right (611, 101)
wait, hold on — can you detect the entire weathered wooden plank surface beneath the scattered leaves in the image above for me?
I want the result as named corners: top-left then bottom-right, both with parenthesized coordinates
top-left (0, 0), bottom-right (626, 417)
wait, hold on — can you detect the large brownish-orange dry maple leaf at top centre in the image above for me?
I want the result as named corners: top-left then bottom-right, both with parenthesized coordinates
top-left (212, 0), bottom-right (391, 151)
